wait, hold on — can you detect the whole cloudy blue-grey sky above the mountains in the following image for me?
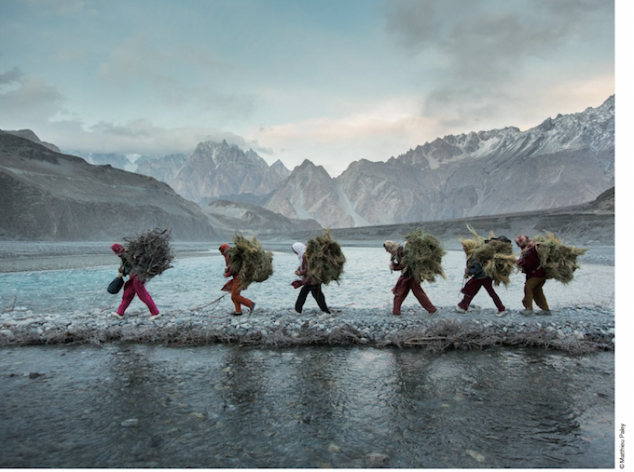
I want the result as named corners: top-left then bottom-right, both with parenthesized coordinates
top-left (0, 0), bottom-right (616, 176)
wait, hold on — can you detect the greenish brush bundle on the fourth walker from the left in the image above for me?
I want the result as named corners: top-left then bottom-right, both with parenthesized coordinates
top-left (401, 229), bottom-right (447, 283)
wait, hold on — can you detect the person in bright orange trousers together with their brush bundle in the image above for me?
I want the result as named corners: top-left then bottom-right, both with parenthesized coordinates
top-left (218, 234), bottom-right (273, 316)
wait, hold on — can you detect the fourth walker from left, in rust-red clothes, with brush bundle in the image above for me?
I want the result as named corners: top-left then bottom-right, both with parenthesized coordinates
top-left (383, 230), bottom-right (446, 316)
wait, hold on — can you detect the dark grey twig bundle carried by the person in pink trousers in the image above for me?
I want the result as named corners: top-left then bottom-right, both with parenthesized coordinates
top-left (124, 228), bottom-right (174, 282)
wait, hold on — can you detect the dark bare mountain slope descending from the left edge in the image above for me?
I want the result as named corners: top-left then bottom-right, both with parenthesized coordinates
top-left (0, 133), bottom-right (215, 240)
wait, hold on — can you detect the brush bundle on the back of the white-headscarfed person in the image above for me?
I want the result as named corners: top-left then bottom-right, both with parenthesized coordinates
top-left (306, 230), bottom-right (346, 285)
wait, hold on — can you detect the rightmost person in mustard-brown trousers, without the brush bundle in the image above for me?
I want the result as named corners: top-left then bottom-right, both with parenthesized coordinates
top-left (515, 235), bottom-right (551, 315)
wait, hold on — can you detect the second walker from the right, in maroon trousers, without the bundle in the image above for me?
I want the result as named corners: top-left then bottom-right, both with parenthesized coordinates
top-left (456, 239), bottom-right (512, 317)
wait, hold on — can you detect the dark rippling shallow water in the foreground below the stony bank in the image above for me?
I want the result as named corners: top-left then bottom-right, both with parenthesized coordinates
top-left (0, 344), bottom-right (615, 468)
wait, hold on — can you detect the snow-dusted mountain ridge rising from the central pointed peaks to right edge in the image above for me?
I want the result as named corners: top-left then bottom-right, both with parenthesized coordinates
top-left (265, 96), bottom-right (614, 228)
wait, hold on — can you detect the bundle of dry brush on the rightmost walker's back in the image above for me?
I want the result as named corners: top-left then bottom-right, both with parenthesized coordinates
top-left (533, 233), bottom-right (588, 284)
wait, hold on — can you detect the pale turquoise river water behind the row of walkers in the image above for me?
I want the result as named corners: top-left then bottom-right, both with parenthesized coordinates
top-left (0, 247), bottom-right (614, 313)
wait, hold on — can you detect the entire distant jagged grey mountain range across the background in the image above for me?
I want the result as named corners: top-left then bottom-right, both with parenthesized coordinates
top-left (1, 96), bottom-right (615, 236)
